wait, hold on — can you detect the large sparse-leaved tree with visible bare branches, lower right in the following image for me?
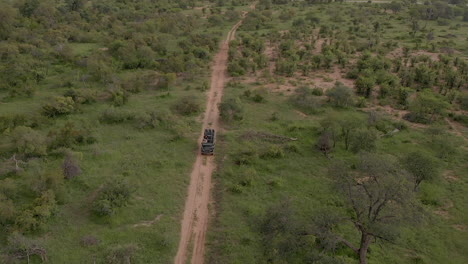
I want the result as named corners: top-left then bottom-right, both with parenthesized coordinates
top-left (325, 153), bottom-right (415, 264)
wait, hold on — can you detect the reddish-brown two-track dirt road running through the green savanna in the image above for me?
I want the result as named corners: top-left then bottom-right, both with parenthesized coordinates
top-left (174, 13), bottom-right (246, 264)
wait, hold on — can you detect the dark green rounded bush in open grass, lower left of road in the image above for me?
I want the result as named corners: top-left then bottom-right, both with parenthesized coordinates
top-left (93, 178), bottom-right (134, 216)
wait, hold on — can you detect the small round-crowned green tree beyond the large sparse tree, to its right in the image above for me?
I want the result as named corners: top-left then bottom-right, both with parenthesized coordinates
top-left (402, 151), bottom-right (439, 191)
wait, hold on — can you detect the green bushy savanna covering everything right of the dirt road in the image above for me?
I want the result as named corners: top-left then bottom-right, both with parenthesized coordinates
top-left (208, 0), bottom-right (468, 263)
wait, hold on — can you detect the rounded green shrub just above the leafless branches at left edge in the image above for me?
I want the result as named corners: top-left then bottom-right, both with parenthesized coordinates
top-left (12, 126), bottom-right (47, 156)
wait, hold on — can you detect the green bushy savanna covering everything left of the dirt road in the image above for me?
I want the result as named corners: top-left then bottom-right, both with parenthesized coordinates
top-left (0, 0), bottom-right (254, 263)
